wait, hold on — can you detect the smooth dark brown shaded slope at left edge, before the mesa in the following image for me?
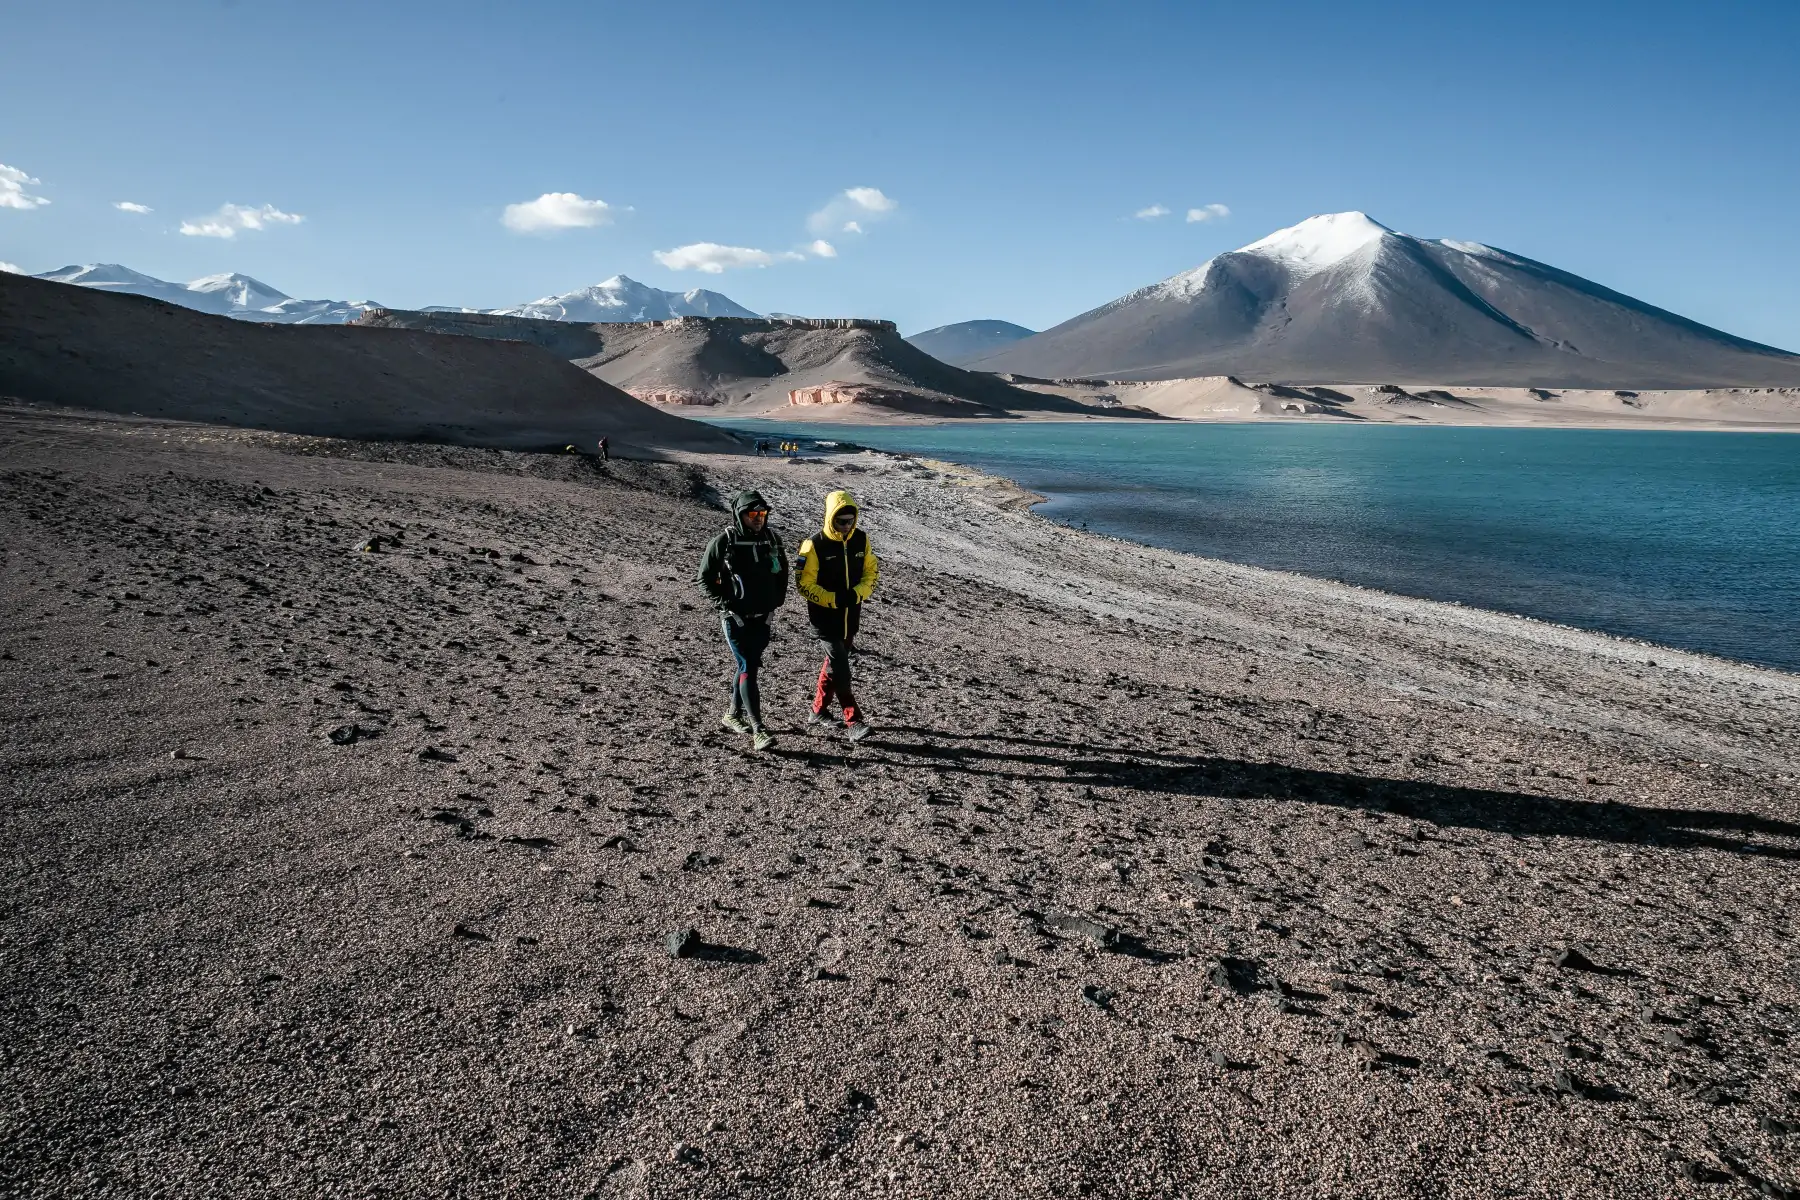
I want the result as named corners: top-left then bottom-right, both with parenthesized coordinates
top-left (0, 275), bottom-right (736, 450)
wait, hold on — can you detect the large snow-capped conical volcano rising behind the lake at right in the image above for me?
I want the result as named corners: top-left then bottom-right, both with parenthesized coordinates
top-left (967, 212), bottom-right (1800, 389)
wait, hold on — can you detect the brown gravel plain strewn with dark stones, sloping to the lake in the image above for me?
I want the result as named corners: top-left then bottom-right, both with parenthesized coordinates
top-left (0, 407), bottom-right (1800, 1198)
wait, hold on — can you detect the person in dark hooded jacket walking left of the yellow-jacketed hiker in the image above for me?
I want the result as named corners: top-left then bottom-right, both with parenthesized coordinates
top-left (697, 491), bottom-right (788, 750)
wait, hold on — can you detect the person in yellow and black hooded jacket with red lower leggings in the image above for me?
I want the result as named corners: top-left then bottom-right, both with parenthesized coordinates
top-left (797, 491), bottom-right (880, 741)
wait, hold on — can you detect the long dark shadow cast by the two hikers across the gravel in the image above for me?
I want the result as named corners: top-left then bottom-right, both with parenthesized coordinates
top-left (814, 727), bottom-right (1800, 860)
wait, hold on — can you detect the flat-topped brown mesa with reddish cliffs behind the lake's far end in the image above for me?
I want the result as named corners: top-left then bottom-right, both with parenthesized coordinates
top-left (362, 309), bottom-right (1101, 417)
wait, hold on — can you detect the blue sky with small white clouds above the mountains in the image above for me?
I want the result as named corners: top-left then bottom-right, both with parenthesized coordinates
top-left (0, 0), bottom-right (1800, 349)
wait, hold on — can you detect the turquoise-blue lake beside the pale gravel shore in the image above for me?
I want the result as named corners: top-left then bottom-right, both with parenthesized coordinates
top-left (709, 421), bottom-right (1800, 671)
